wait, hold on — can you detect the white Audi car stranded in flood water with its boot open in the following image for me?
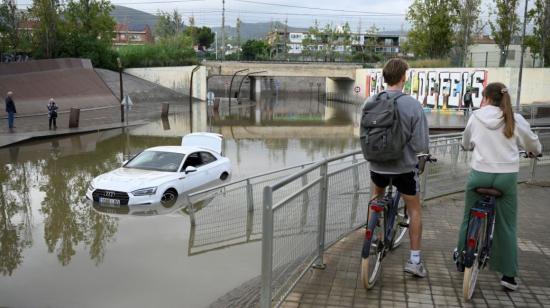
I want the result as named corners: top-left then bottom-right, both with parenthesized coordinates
top-left (86, 133), bottom-right (231, 206)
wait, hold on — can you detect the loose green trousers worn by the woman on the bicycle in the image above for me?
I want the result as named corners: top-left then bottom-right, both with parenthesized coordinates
top-left (457, 170), bottom-right (518, 277)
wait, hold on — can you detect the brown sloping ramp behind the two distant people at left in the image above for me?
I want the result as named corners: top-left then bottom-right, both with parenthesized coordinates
top-left (0, 59), bottom-right (119, 116)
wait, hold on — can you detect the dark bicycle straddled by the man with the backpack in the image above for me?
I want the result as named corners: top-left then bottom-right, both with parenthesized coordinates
top-left (361, 154), bottom-right (437, 290)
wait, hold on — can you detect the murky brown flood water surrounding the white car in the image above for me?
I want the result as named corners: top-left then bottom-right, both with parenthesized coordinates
top-left (0, 96), bottom-right (359, 307)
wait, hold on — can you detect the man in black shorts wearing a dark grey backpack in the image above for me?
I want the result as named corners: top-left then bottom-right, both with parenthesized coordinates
top-left (360, 58), bottom-right (429, 277)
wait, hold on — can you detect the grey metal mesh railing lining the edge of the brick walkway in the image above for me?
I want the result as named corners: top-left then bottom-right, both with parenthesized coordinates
top-left (260, 128), bottom-right (550, 308)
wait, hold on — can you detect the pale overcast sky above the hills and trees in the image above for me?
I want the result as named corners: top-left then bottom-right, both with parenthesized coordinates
top-left (17, 0), bottom-right (536, 31)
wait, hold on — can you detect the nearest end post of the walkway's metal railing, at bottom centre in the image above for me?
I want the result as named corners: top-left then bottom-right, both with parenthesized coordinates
top-left (260, 186), bottom-right (273, 308)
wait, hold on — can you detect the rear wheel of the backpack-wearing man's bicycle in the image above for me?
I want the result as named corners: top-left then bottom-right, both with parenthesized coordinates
top-left (361, 213), bottom-right (384, 290)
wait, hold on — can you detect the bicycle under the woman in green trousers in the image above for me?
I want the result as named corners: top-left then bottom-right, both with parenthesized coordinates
top-left (457, 151), bottom-right (542, 300)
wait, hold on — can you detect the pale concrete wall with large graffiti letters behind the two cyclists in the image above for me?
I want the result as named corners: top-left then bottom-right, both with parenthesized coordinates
top-left (354, 67), bottom-right (550, 107)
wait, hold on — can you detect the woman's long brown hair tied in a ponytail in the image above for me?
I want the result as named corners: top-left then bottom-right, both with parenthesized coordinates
top-left (483, 82), bottom-right (516, 138)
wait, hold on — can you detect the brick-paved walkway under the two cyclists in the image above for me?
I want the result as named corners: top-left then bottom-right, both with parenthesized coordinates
top-left (283, 184), bottom-right (550, 308)
